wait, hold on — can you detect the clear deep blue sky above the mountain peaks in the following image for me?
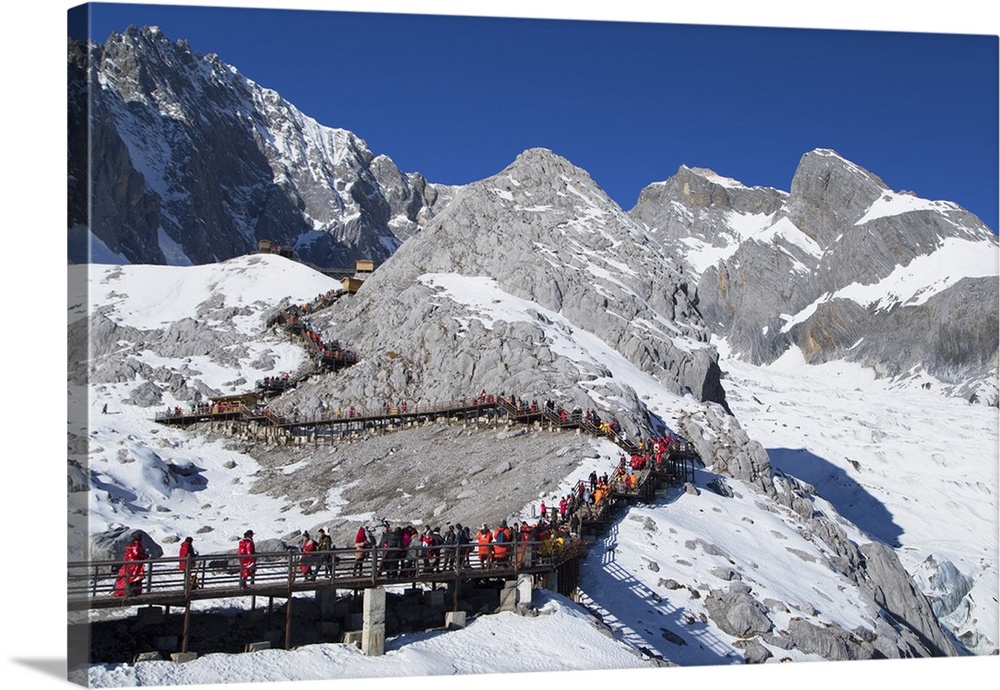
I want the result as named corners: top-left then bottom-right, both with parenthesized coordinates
top-left (72, 4), bottom-right (998, 231)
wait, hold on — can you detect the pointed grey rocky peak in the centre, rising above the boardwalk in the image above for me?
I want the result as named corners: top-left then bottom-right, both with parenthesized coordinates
top-left (278, 149), bottom-right (725, 433)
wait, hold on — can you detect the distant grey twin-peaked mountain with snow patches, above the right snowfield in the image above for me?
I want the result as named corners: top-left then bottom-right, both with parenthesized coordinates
top-left (629, 149), bottom-right (1000, 404)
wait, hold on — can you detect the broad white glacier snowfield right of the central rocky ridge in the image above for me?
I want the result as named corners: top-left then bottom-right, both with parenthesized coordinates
top-left (719, 342), bottom-right (1000, 648)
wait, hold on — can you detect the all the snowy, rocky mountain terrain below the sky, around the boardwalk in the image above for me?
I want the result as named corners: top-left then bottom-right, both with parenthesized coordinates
top-left (68, 22), bottom-right (1000, 685)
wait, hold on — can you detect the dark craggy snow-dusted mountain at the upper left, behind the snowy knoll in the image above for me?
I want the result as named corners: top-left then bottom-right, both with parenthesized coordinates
top-left (68, 27), bottom-right (452, 267)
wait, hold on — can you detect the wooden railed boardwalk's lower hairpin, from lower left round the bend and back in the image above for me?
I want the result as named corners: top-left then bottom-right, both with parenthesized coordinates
top-left (82, 396), bottom-right (700, 651)
